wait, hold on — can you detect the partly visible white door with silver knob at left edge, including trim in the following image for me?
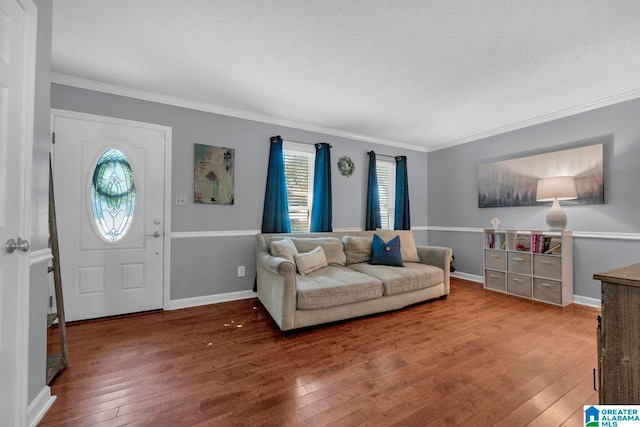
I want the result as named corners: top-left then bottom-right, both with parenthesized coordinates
top-left (0, 0), bottom-right (35, 426)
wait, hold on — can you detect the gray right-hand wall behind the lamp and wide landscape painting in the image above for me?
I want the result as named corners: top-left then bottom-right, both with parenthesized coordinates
top-left (427, 100), bottom-right (640, 299)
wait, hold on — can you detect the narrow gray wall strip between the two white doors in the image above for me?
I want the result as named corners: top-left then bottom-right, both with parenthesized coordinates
top-left (27, 0), bottom-right (52, 402)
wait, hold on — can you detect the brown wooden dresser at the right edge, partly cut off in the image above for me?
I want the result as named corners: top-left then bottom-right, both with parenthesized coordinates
top-left (593, 263), bottom-right (640, 405)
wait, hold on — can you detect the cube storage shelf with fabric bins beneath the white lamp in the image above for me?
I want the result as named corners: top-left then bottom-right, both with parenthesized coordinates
top-left (484, 228), bottom-right (573, 307)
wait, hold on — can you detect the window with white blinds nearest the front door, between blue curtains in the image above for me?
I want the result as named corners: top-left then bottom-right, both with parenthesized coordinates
top-left (282, 141), bottom-right (316, 233)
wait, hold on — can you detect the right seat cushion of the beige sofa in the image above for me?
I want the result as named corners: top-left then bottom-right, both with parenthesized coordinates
top-left (349, 262), bottom-right (444, 295)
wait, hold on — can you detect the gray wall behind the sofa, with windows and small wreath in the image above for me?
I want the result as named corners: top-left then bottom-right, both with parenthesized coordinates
top-left (51, 84), bottom-right (427, 300)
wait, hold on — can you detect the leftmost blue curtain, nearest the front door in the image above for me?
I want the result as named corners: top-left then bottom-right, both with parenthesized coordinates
top-left (262, 135), bottom-right (291, 233)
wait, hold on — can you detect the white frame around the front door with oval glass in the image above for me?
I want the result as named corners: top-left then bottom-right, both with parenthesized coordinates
top-left (51, 108), bottom-right (172, 310)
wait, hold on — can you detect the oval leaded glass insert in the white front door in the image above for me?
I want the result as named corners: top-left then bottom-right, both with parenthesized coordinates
top-left (91, 148), bottom-right (136, 243)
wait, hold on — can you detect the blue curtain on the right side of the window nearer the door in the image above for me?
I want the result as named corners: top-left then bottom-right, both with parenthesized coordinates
top-left (309, 142), bottom-right (333, 233)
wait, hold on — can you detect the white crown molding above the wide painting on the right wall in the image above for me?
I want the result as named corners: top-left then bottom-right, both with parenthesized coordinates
top-left (429, 89), bottom-right (640, 152)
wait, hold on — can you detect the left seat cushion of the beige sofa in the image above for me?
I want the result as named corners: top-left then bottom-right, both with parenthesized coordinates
top-left (296, 264), bottom-right (383, 310)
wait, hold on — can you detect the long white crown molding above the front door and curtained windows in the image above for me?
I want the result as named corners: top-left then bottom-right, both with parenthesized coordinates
top-left (51, 73), bottom-right (429, 152)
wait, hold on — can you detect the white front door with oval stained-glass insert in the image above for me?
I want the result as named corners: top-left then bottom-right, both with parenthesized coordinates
top-left (53, 112), bottom-right (168, 321)
